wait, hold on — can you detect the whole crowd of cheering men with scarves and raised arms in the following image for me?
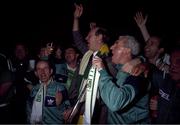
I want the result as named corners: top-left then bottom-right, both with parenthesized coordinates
top-left (0, 4), bottom-right (180, 124)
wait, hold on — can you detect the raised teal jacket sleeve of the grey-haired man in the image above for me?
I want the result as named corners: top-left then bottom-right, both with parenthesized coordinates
top-left (99, 70), bottom-right (135, 111)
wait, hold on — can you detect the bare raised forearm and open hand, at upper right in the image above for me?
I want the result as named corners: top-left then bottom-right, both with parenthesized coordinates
top-left (134, 12), bottom-right (150, 42)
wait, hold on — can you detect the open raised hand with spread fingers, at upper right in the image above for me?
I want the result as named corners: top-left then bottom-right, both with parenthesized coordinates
top-left (134, 12), bottom-right (148, 28)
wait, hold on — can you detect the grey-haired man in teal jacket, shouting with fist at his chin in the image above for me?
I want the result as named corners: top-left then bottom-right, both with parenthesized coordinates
top-left (93, 36), bottom-right (149, 124)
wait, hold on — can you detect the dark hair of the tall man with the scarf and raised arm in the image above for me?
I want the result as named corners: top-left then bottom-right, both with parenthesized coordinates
top-left (95, 27), bottom-right (110, 43)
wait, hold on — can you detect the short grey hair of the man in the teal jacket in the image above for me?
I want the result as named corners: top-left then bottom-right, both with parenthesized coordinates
top-left (119, 35), bottom-right (140, 56)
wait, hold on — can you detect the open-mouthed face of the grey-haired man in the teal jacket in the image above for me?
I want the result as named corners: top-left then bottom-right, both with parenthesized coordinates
top-left (111, 39), bottom-right (130, 64)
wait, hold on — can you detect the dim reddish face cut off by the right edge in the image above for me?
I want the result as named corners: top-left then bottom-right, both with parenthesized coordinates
top-left (169, 50), bottom-right (180, 81)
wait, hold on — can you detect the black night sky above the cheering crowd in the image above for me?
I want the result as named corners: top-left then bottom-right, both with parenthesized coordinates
top-left (0, 0), bottom-right (180, 56)
